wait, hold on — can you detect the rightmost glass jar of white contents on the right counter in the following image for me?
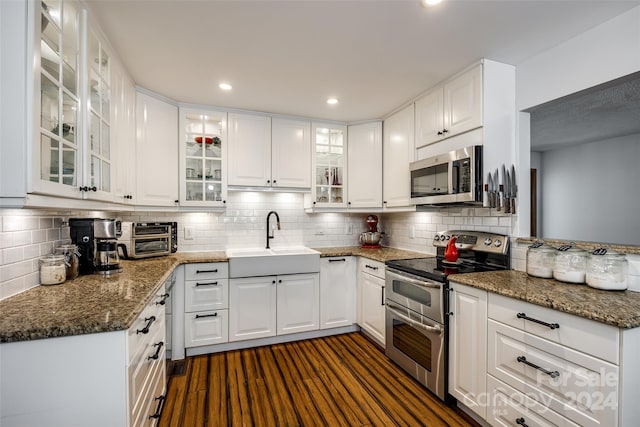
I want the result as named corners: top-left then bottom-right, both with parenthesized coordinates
top-left (586, 249), bottom-right (629, 291)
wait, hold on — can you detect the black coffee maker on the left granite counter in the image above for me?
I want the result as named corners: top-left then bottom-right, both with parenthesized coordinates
top-left (69, 218), bottom-right (122, 275)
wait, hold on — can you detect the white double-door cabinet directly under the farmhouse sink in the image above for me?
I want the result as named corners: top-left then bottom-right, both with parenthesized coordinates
top-left (229, 273), bottom-right (320, 342)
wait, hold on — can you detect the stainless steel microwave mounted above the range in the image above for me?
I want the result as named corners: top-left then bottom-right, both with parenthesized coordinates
top-left (409, 145), bottom-right (482, 205)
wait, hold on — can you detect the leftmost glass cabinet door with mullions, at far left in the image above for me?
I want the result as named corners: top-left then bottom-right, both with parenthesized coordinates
top-left (38, 0), bottom-right (80, 187)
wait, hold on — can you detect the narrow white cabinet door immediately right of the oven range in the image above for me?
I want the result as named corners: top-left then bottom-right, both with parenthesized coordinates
top-left (449, 283), bottom-right (487, 419)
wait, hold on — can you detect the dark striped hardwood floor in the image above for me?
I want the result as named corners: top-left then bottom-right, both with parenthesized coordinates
top-left (159, 333), bottom-right (477, 427)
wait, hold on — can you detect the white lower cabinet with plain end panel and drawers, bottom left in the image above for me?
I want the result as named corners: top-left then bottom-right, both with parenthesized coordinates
top-left (0, 286), bottom-right (167, 427)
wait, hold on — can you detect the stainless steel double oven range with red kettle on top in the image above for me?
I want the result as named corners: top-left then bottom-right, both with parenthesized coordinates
top-left (385, 230), bottom-right (510, 400)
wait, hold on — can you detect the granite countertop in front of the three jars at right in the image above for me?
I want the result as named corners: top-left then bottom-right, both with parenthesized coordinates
top-left (449, 270), bottom-right (640, 329)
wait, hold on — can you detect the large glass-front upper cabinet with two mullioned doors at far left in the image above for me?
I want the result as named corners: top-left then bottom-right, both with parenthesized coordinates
top-left (34, 0), bottom-right (112, 200)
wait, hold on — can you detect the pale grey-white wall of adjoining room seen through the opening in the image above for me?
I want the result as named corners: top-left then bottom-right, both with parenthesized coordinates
top-left (540, 134), bottom-right (640, 246)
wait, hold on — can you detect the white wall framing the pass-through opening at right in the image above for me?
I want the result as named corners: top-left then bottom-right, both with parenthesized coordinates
top-left (514, 6), bottom-right (640, 236)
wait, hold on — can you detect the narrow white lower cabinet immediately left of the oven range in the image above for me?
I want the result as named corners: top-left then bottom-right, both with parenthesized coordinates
top-left (358, 258), bottom-right (386, 347)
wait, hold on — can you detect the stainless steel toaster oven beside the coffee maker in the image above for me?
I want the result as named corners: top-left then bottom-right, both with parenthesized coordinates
top-left (118, 222), bottom-right (178, 259)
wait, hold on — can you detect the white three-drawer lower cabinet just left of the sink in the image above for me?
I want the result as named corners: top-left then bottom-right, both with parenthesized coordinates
top-left (184, 262), bottom-right (229, 348)
